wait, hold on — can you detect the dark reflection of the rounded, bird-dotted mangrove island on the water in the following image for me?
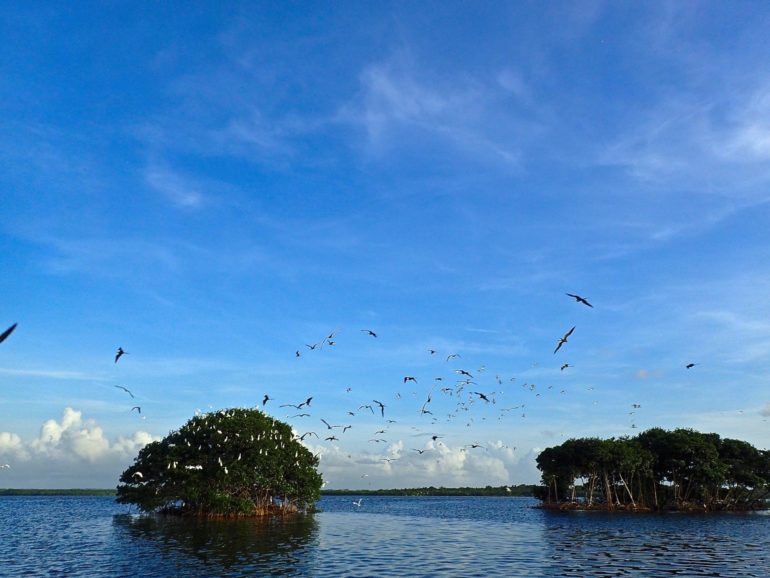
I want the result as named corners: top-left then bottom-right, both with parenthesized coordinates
top-left (113, 514), bottom-right (318, 576)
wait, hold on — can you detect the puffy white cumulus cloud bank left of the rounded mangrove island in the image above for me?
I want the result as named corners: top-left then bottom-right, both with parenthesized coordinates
top-left (0, 407), bottom-right (155, 488)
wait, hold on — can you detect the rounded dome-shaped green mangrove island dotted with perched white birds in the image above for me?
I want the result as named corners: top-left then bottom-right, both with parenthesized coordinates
top-left (117, 408), bottom-right (322, 517)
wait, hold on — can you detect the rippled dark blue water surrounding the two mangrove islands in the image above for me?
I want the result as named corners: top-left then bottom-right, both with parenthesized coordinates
top-left (0, 496), bottom-right (770, 578)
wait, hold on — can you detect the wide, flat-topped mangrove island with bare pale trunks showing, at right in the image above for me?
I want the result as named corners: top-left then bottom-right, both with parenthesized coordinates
top-left (535, 428), bottom-right (770, 511)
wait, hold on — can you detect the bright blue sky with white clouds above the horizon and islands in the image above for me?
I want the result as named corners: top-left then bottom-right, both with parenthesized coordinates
top-left (0, 2), bottom-right (770, 488)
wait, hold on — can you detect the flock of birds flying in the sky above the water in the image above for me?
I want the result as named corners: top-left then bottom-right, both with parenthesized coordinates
top-left (0, 293), bottom-right (696, 490)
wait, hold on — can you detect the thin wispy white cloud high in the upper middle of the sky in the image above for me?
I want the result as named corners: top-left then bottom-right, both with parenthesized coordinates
top-left (339, 51), bottom-right (544, 168)
